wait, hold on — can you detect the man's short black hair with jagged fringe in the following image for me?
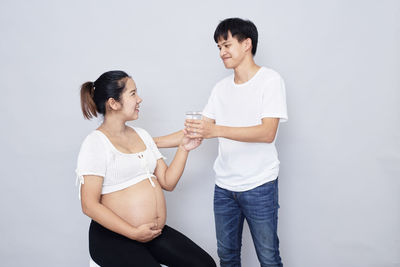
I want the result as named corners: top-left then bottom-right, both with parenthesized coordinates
top-left (214, 18), bottom-right (258, 56)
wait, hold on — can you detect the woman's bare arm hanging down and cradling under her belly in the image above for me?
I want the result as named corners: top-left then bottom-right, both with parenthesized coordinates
top-left (81, 175), bottom-right (161, 242)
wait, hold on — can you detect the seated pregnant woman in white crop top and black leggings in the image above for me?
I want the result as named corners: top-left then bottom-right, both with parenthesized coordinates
top-left (76, 71), bottom-right (216, 267)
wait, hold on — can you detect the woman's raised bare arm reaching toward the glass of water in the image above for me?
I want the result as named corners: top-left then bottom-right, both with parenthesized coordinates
top-left (154, 130), bottom-right (201, 191)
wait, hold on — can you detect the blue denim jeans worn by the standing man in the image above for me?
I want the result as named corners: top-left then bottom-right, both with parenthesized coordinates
top-left (214, 179), bottom-right (283, 267)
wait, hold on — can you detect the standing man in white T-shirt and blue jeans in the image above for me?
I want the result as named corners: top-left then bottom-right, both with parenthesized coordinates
top-left (155, 18), bottom-right (288, 267)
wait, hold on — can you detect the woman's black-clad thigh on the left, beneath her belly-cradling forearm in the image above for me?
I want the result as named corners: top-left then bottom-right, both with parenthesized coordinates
top-left (89, 221), bottom-right (160, 267)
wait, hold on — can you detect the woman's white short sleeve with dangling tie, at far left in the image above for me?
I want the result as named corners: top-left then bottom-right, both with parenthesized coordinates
top-left (76, 132), bottom-right (107, 197)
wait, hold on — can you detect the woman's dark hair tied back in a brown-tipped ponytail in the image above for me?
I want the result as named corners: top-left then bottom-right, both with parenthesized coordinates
top-left (81, 70), bottom-right (130, 120)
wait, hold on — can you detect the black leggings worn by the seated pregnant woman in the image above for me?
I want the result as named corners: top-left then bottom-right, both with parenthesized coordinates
top-left (89, 220), bottom-right (216, 267)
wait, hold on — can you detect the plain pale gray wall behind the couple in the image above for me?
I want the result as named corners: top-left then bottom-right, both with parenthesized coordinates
top-left (0, 0), bottom-right (400, 267)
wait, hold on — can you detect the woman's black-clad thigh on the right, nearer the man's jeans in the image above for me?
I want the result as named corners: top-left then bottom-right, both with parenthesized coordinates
top-left (146, 225), bottom-right (216, 267)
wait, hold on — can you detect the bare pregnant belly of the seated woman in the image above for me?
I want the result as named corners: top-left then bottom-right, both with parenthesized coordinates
top-left (101, 179), bottom-right (167, 229)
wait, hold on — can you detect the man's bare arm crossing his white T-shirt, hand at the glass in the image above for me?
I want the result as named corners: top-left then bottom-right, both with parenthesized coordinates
top-left (185, 117), bottom-right (279, 143)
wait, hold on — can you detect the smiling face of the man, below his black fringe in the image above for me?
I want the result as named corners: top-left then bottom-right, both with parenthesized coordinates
top-left (217, 32), bottom-right (247, 69)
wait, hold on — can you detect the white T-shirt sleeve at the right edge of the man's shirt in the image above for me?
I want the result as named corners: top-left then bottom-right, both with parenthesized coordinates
top-left (261, 76), bottom-right (288, 122)
